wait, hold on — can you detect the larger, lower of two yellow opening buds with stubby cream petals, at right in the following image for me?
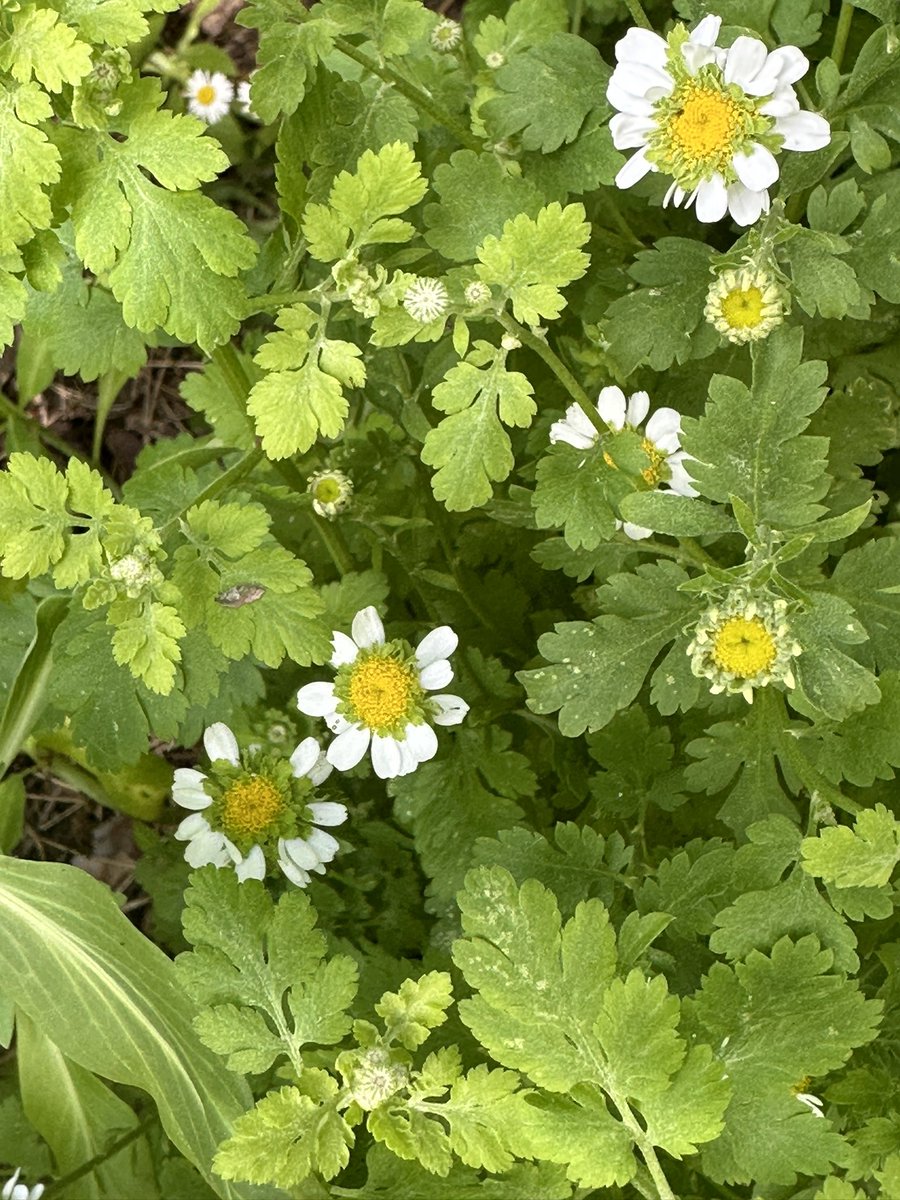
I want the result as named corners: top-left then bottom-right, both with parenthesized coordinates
top-left (688, 588), bottom-right (802, 703)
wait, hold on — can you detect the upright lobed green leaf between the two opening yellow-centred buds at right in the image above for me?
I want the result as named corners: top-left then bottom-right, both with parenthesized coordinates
top-left (682, 329), bottom-right (828, 529)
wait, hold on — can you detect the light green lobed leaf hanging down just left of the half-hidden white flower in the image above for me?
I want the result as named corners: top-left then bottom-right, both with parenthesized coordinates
top-left (422, 343), bottom-right (535, 512)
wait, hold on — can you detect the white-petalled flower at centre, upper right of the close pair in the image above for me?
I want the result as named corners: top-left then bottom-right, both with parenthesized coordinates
top-left (296, 606), bottom-right (469, 779)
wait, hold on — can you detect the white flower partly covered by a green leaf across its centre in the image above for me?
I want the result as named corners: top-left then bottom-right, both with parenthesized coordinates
top-left (550, 386), bottom-right (697, 540)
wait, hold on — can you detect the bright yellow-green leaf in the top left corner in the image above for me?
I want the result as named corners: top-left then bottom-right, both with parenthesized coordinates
top-left (0, 4), bottom-right (91, 91)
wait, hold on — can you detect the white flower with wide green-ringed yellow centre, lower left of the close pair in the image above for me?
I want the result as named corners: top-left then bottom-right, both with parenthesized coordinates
top-left (172, 721), bottom-right (347, 888)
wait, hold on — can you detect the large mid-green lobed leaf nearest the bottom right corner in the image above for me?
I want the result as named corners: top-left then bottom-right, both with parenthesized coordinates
top-left (684, 936), bottom-right (881, 1186)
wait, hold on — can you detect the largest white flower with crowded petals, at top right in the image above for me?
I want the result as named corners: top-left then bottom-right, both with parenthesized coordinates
top-left (606, 16), bottom-right (830, 226)
